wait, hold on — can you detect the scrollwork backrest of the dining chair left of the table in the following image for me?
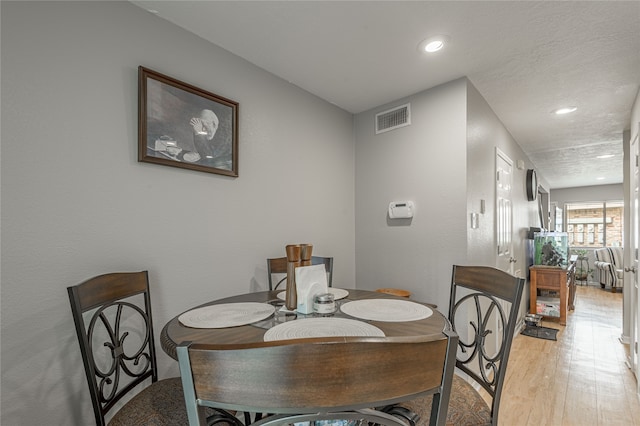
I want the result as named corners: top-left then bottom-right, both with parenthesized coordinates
top-left (67, 271), bottom-right (158, 425)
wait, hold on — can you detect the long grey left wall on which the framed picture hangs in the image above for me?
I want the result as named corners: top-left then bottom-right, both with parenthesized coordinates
top-left (1, 1), bottom-right (355, 425)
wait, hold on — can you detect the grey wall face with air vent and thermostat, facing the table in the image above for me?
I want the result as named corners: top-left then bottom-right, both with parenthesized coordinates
top-left (355, 79), bottom-right (467, 312)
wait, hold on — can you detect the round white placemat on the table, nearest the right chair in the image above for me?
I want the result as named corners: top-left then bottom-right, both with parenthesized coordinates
top-left (340, 299), bottom-right (433, 322)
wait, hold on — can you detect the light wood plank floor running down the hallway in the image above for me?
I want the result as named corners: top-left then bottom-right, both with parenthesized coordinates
top-left (499, 285), bottom-right (640, 426)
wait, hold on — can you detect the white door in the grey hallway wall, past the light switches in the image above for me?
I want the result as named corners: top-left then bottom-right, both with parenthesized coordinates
top-left (496, 148), bottom-right (515, 274)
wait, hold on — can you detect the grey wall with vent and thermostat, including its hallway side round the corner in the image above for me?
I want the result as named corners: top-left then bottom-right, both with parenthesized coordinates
top-left (355, 78), bottom-right (539, 315)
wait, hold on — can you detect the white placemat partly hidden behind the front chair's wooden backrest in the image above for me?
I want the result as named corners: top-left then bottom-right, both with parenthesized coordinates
top-left (264, 317), bottom-right (384, 342)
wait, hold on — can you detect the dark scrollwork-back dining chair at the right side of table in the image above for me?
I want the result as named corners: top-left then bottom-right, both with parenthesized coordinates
top-left (385, 266), bottom-right (525, 426)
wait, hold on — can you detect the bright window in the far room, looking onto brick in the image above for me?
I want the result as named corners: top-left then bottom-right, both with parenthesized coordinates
top-left (565, 201), bottom-right (624, 247)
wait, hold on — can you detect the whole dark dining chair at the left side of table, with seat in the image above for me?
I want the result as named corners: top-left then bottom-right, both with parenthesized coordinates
top-left (67, 271), bottom-right (238, 426)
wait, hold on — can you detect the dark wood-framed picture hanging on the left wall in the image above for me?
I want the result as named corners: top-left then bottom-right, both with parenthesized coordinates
top-left (138, 66), bottom-right (238, 177)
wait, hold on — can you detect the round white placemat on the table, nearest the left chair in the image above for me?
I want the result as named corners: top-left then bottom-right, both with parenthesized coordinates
top-left (178, 302), bottom-right (275, 328)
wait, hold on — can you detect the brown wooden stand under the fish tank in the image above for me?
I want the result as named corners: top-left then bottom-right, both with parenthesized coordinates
top-left (529, 263), bottom-right (576, 325)
